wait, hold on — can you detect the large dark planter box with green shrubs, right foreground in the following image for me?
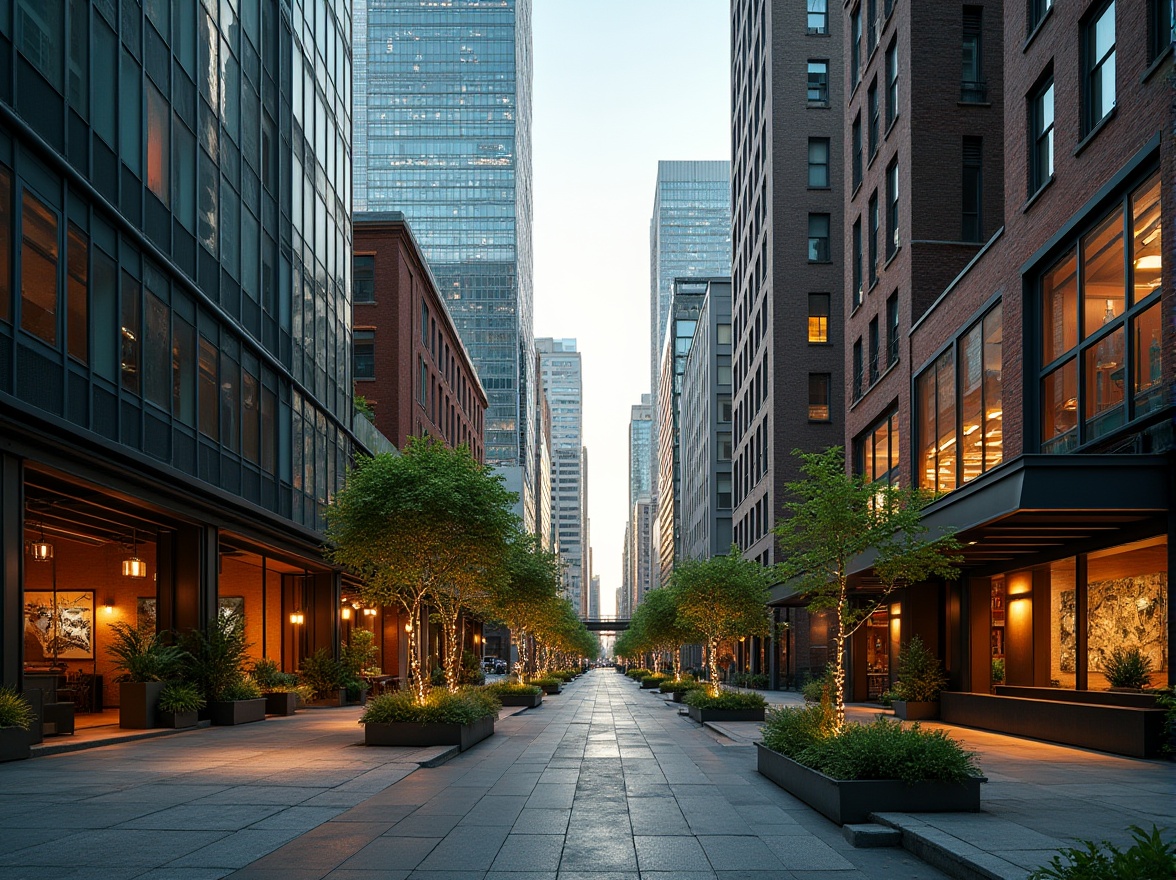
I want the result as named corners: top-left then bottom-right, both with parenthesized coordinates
top-left (755, 701), bottom-right (985, 825)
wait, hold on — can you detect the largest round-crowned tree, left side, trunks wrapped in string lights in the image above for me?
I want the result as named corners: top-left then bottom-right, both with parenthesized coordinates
top-left (327, 438), bottom-right (517, 700)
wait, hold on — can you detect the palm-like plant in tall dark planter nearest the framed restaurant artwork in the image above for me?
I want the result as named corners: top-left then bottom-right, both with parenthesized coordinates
top-left (106, 621), bottom-right (187, 729)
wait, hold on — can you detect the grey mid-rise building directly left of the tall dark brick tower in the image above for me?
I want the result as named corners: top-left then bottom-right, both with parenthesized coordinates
top-left (680, 281), bottom-right (731, 559)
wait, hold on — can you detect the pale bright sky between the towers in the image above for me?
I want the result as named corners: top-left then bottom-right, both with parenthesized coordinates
top-left (532, 0), bottom-right (730, 614)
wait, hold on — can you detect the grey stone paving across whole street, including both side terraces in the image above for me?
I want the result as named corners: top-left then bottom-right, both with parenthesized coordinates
top-left (0, 669), bottom-right (1176, 880)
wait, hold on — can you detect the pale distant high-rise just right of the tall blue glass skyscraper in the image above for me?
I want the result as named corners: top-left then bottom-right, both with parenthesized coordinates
top-left (535, 338), bottom-right (588, 613)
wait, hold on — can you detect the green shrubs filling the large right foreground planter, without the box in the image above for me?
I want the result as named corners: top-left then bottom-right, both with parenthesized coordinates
top-left (763, 704), bottom-right (981, 785)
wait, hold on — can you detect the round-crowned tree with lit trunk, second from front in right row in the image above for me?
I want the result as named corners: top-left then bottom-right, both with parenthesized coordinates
top-left (672, 546), bottom-right (773, 693)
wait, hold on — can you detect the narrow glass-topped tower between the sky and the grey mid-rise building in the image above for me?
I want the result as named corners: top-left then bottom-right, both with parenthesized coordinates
top-left (653, 278), bottom-right (710, 587)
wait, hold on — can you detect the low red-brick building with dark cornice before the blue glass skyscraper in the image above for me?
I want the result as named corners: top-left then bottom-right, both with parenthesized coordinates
top-left (353, 212), bottom-right (487, 461)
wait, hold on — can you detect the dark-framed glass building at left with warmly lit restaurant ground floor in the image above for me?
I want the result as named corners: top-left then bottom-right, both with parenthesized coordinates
top-left (0, 0), bottom-right (355, 704)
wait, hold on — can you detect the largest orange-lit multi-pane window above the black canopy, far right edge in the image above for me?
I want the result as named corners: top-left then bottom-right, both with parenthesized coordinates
top-left (1040, 174), bottom-right (1164, 452)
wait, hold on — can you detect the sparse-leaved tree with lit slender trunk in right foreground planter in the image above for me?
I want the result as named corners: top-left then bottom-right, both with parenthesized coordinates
top-left (775, 446), bottom-right (960, 731)
